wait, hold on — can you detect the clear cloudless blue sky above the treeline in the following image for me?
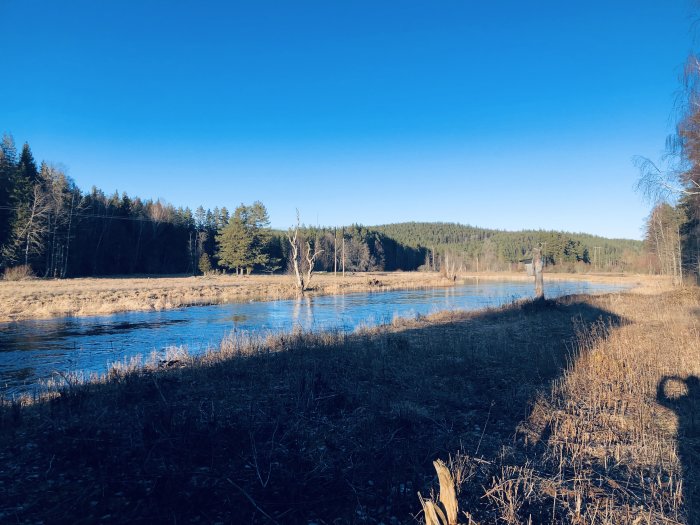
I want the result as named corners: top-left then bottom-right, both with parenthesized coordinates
top-left (0, 0), bottom-right (693, 238)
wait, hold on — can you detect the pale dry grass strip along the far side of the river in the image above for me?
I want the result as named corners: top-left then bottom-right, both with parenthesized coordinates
top-left (0, 272), bottom-right (662, 322)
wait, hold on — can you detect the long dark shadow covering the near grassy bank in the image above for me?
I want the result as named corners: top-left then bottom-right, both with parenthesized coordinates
top-left (0, 297), bottom-right (622, 523)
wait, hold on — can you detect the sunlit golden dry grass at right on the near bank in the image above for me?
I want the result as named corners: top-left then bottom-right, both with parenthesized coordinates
top-left (422, 289), bottom-right (700, 525)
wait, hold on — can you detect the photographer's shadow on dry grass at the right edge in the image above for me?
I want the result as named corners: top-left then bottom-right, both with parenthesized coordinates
top-left (656, 376), bottom-right (700, 524)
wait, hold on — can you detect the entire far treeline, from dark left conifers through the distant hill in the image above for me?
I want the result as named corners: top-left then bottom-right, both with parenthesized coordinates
top-left (0, 134), bottom-right (650, 278)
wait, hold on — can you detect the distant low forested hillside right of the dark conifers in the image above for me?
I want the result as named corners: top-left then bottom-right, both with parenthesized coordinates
top-left (368, 222), bottom-right (645, 271)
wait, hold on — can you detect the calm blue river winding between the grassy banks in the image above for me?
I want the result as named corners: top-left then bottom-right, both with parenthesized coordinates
top-left (0, 281), bottom-right (624, 395)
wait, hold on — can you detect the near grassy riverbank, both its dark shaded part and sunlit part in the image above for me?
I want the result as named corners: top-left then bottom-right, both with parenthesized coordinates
top-left (0, 284), bottom-right (700, 525)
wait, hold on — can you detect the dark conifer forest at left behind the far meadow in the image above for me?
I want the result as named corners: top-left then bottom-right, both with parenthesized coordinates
top-left (0, 134), bottom-right (425, 278)
